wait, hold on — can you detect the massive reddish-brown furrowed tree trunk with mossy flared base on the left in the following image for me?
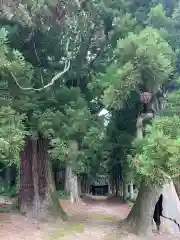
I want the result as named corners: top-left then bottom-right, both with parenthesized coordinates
top-left (19, 139), bottom-right (65, 220)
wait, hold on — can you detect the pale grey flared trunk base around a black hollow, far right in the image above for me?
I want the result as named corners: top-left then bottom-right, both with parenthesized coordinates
top-left (122, 182), bottom-right (180, 237)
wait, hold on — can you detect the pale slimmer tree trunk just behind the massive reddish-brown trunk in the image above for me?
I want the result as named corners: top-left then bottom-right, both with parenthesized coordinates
top-left (66, 164), bottom-right (80, 203)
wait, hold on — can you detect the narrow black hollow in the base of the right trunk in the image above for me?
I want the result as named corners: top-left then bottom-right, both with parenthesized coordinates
top-left (153, 194), bottom-right (163, 233)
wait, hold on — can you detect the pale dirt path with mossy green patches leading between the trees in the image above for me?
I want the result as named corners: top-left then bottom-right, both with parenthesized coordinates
top-left (0, 198), bottom-right (180, 240)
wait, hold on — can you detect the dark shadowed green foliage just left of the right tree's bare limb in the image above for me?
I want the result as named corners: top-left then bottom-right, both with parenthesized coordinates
top-left (107, 96), bottom-right (141, 184)
